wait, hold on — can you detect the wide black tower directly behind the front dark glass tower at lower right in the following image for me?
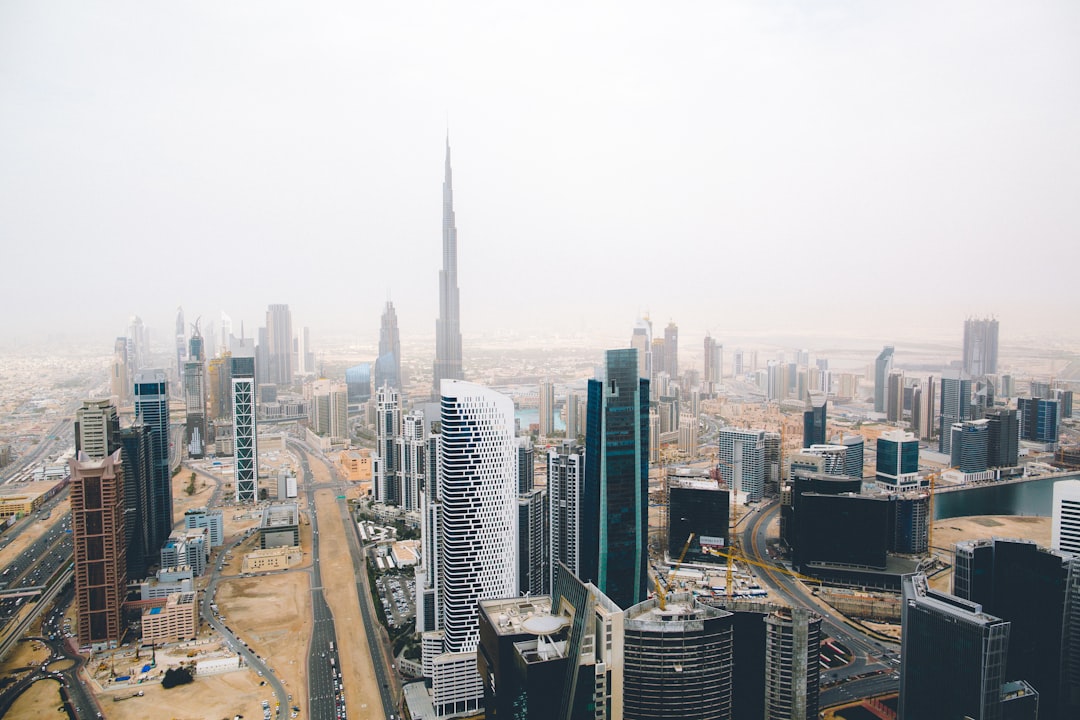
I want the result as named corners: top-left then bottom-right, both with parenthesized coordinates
top-left (953, 539), bottom-right (1080, 720)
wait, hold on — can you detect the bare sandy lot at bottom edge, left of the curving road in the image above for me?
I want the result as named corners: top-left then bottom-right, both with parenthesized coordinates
top-left (99, 671), bottom-right (270, 720)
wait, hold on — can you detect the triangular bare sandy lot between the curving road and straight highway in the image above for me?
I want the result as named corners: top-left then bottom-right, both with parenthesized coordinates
top-left (216, 571), bottom-right (311, 708)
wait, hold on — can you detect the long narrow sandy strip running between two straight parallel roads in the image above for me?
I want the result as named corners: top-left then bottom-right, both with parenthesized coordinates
top-left (310, 458), bottom-right (386, 720)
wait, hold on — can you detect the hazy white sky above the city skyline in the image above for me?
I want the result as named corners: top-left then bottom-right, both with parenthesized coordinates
top-left (0, 0), bottom-right (1080, 344)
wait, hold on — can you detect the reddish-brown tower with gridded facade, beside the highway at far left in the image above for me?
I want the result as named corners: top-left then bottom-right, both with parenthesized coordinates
top-left (68, 449), bottom-right (127, 648)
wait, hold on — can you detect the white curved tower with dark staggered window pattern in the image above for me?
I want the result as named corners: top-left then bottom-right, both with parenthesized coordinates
top-left (438, 379), bottom-right (517, 653)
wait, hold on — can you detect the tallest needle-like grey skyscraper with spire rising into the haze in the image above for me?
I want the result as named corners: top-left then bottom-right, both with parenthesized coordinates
top-left (432, 137), bottom-right (464, 398)
